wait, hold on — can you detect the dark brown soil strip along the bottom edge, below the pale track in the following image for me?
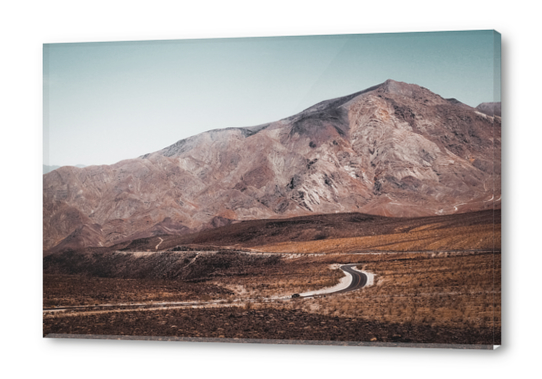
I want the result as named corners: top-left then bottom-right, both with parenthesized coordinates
top-left (44, 307), bottom-right (500, 344)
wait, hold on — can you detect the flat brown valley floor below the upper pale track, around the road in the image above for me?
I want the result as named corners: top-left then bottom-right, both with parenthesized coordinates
top-left (43, 250), bottom-right (501, 347)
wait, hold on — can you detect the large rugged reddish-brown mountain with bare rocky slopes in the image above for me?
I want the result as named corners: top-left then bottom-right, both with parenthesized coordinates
top-left (43, 80), bottom-right (501, 251)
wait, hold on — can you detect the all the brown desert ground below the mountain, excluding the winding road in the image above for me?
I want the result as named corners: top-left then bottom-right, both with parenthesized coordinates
top-left (44, 212), bottom-right (501, 347)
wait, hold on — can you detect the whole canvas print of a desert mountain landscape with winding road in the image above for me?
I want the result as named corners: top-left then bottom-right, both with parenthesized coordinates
top-left (42, 30), bottom-right (501, 349)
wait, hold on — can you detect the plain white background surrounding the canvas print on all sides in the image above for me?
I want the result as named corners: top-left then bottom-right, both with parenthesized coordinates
top-left (0, 0), bottom-right (542, 378)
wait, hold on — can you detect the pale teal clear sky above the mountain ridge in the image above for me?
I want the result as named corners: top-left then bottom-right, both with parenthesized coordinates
top-left (43, 31), bottom-right (500, 166)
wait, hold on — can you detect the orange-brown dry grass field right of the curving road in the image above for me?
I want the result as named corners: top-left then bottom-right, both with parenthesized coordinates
top-left (278, 254), bottom-right (501, 330)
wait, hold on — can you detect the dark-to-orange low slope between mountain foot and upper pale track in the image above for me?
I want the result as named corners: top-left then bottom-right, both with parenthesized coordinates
top-left (111, 209), bottom-right (501, 252)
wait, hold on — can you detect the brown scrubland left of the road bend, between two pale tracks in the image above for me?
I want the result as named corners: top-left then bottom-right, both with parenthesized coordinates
top-left (44, 252), bottom-right (346, 305)
